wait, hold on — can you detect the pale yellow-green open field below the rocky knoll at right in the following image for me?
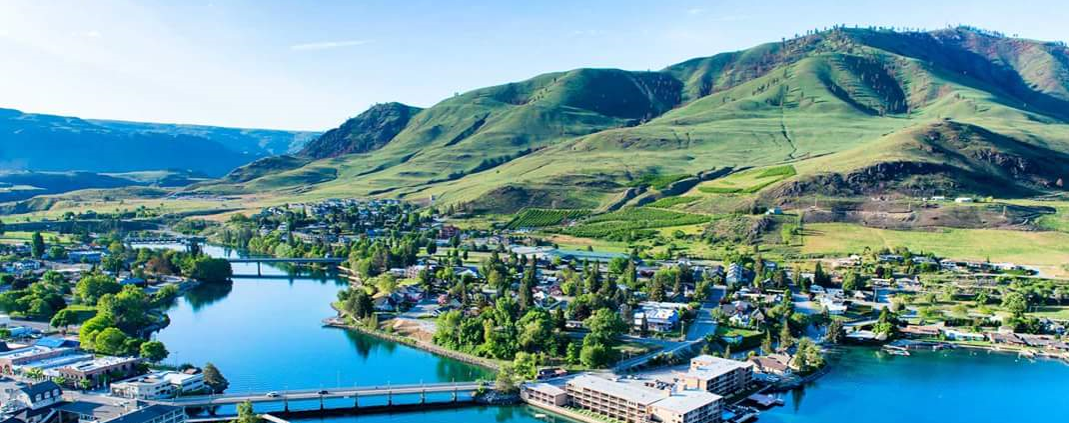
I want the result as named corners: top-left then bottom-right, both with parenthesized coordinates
top-left (802, 223), bottom-right (1069, 267)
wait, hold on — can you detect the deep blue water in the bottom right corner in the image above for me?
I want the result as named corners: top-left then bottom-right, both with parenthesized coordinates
top-left (760, 348), bottom-right (1069, 423)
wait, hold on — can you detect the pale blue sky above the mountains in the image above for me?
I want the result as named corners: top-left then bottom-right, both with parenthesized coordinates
top-left (0, 0), bottom-right (1069, 129)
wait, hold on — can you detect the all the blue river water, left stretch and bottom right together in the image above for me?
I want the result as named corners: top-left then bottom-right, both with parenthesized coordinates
top-left (146, 247), bottom-right (1069, 423)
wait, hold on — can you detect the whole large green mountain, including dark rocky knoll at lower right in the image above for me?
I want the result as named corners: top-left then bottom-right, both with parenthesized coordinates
top-left (197, 27), bottom-right (1069, 212)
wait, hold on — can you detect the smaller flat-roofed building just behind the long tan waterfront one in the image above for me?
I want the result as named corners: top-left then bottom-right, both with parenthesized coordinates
top-left (676, 355), bottom-right (754, 396)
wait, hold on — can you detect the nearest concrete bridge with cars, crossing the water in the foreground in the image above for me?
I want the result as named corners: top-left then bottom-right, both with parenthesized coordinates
top-left (150, 381), bottom-right (483, 411)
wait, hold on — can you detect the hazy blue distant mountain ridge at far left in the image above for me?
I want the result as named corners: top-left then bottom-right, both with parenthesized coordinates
top-left (0, 109), bottom-right (317, 176)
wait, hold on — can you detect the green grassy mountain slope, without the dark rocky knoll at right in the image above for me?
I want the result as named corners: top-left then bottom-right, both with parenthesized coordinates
top-left (194, 30), bottom-right (1069, 213)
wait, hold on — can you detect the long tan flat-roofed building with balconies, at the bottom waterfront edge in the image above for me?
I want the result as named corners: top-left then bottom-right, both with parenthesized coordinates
top-left (566, 375), bottom-right (723, 423)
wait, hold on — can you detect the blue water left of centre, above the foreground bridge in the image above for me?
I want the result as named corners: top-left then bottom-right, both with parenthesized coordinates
top-left (156, 247), bottom-right (491, 392)
